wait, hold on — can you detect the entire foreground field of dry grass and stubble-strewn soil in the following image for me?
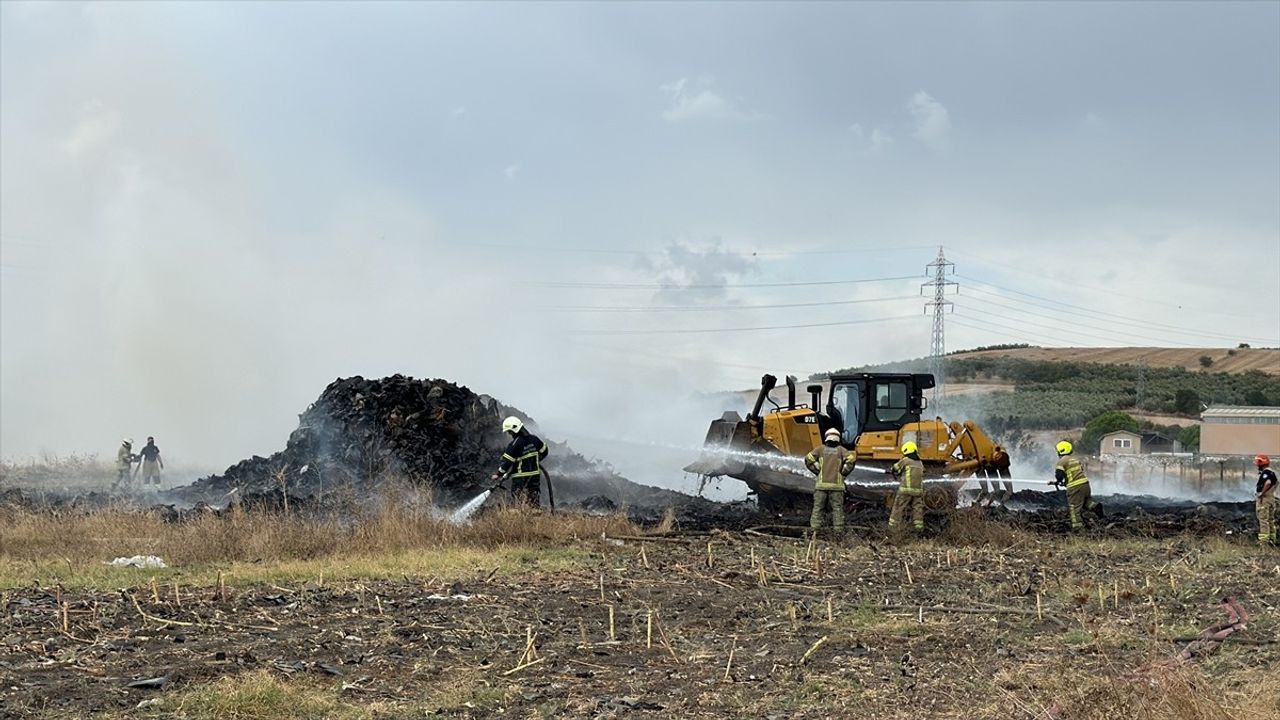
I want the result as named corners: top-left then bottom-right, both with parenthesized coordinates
top-left (0, 503), bottom-right (1280, 720)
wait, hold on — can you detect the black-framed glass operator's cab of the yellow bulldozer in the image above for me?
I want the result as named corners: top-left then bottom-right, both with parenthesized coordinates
top-left (818, 373), bottom-right (933, 447)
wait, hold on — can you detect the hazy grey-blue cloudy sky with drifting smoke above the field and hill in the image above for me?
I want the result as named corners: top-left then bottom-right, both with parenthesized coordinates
top-left (0, 1), bottom-right (1280, 468)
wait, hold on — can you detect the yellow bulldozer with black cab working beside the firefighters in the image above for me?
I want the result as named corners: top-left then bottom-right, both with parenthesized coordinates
top-left (685, 373), bottom-right (996, 511)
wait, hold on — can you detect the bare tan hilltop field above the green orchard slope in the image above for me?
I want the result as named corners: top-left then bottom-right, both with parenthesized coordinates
top-left (947, 347), bottom-right (1280, 375)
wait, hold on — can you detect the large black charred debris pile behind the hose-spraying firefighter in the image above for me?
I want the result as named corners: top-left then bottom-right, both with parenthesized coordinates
top-left (170, 374), bottom-right (747, 515)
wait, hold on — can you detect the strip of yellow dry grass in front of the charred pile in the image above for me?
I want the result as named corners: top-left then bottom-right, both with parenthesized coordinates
top-left (0, 498), bottom-right (637, 587)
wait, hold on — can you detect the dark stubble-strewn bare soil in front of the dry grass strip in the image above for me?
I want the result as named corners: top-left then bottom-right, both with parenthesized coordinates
top-left (0, 533), bottom-right (1280, 719)
